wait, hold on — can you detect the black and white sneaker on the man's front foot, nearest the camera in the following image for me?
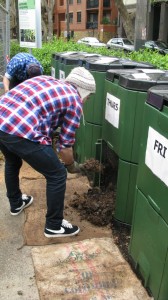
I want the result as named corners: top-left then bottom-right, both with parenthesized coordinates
top-left (44, 219), bottom-right (80, 238)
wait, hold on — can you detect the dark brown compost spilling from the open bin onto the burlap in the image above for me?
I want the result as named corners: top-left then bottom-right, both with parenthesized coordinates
top-left (70, 159), bottom-right (130, 261)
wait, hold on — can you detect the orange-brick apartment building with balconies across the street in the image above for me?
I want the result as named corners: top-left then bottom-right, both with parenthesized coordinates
top-left (54, 0), bottom-right (118, 42)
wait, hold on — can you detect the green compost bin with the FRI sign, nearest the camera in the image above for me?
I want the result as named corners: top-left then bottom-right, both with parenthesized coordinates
top-left (129, 85), bottom-right (168, 300)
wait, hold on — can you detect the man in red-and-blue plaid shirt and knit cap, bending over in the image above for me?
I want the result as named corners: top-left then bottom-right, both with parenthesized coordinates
top-left (0, 67), bottom-right (96, 238)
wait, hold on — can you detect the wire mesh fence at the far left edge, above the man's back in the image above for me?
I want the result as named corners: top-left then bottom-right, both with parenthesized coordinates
top-left (0, 2), bottom-right (10, 94)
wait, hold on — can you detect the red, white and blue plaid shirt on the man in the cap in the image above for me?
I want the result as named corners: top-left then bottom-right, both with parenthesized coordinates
top-left (0, 75), bottom-right (82, 148)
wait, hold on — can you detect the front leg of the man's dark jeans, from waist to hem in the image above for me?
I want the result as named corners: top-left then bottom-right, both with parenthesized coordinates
top-left (0, 131), bottom-right (67, 229)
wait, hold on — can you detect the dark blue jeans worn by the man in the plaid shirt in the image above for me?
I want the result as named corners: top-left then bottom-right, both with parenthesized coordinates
top-left (0, 131), bottom-right (67, 229)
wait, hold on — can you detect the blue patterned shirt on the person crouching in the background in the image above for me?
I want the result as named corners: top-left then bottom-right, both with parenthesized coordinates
top-left (5, 53), bottom-right (43, 82)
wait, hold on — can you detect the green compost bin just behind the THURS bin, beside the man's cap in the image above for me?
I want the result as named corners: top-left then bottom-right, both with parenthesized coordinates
top-left (74, 56), bottom-right (153, 166)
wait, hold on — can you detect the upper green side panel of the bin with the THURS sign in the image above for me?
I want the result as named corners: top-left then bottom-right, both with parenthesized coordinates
top-left (103, 82), bottom-right (138, 163)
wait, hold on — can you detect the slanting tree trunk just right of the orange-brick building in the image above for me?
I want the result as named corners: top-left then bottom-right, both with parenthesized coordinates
top-left (114, 0), bottom-right (134, 40)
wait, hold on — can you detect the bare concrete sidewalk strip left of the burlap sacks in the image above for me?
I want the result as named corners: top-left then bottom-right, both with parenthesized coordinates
top-left (0, 173), bottom-right (40, 300)
